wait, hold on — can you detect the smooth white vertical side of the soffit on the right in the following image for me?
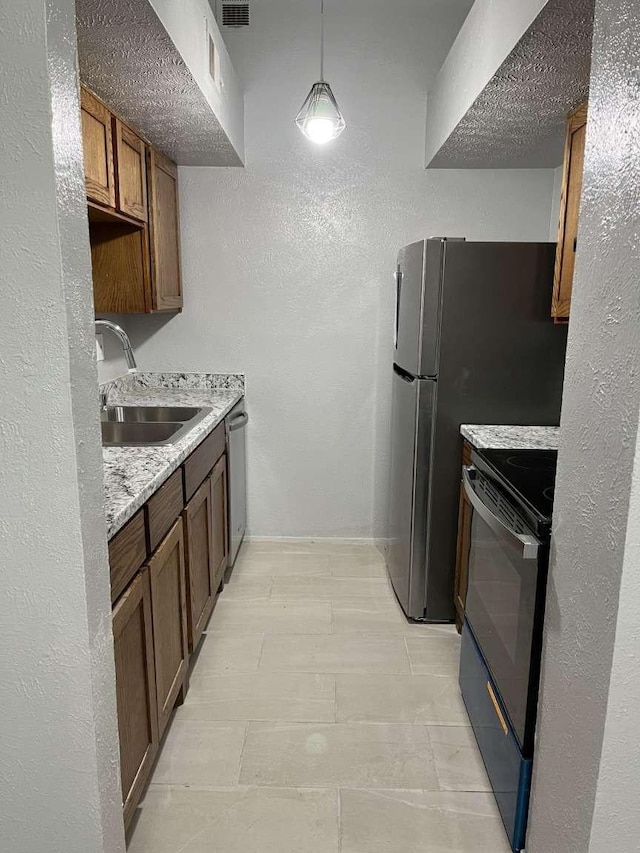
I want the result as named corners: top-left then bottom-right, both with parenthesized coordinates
top-left (425, 0), bottom-right (548, 166)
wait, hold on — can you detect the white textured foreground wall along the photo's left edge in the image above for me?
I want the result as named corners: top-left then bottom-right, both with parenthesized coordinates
top-left (0, 0), bottom-right (124, 853)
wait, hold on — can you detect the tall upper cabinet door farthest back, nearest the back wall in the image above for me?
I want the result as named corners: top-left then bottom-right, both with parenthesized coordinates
top-left (147, 148), bottom-right (182, 311)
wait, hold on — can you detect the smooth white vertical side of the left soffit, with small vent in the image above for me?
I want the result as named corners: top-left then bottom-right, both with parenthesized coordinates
top-left (150, 0), bottom-right (244, 162)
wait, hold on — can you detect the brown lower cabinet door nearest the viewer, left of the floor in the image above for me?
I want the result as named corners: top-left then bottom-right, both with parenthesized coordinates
top-left (113, 569), bottom-right (159, 826)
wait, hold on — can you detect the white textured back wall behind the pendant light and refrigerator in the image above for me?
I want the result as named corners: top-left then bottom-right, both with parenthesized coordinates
top-left (103, 0), bottom-right (553, 537)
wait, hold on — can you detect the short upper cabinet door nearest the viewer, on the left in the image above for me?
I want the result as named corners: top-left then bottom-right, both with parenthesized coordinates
top-left (80, 88), bottom-right (116, 207)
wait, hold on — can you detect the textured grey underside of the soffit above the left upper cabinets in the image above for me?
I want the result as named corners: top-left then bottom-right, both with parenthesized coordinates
top-left (76, 0), bottom-right (242, 166)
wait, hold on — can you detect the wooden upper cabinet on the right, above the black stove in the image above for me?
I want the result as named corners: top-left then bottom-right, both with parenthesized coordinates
top-left (551, 103), bottom-right (587, 322)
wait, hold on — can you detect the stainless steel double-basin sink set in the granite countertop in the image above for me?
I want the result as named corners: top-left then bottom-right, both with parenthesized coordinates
top-left (101, 406), bottom-right (213, 447)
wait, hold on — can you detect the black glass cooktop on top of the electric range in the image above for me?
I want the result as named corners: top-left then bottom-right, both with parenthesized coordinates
top-left (474, 450), bottom-right (558, 522)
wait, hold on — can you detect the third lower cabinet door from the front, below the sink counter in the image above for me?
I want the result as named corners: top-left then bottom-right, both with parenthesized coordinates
top-left (183, 477), bottom-right (217, 651)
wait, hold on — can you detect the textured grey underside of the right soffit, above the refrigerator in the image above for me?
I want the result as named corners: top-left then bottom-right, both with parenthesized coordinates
top-left (428, 0), bottom-right (594, 169)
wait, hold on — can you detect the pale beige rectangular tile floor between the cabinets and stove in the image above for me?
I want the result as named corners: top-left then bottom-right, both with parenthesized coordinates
top-left (129, 542), bottom-right (510, 853)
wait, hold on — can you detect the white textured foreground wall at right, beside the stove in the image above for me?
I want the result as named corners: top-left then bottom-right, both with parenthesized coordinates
top-left (527, 0), bottom-right (640, 853)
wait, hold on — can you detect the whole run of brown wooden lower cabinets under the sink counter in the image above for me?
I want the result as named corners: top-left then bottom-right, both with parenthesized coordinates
top-left (109, 440), bottom-right (228, 827)
